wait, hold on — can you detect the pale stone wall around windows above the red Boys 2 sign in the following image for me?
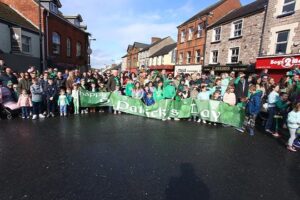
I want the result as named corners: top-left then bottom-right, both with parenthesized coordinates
top-left (262, 0), bottom-right (300, 55)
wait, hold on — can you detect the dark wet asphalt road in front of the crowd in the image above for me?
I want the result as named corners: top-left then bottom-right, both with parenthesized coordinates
top-left (0, 114), bottom-right (300, 200)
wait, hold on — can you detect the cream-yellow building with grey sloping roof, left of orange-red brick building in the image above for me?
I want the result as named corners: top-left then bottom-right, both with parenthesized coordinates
top-left (149, 43), bottom-right (177, 73)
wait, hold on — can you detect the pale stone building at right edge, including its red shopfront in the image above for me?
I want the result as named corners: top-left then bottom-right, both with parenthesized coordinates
top-left (256, 0), bottom-right (300, 80)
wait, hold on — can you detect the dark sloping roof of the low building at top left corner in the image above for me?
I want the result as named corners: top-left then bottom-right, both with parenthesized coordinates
top-left (0, 2), bottom-right (39, 32)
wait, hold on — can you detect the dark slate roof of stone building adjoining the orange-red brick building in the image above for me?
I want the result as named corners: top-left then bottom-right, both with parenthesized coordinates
top-left (209, 0), bottom-right (268, 28)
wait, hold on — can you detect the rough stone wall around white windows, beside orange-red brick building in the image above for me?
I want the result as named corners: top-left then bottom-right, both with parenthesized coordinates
top-left (205, 12), bottom-right (264, 66)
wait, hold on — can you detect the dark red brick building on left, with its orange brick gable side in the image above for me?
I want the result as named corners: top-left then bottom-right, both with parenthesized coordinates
top-left (0, 0), bottom-right (90, 70)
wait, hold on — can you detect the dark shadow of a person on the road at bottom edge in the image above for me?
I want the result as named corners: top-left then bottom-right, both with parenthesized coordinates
top-left (165, 163), bottom-right (210, 200)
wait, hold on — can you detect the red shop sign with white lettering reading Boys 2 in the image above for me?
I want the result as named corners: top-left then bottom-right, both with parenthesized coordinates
top-left (256, 55), bottom-right (300, 69)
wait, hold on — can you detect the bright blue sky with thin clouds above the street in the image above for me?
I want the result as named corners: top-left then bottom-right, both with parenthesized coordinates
top-left (60, 0), bottom-right (254, 68)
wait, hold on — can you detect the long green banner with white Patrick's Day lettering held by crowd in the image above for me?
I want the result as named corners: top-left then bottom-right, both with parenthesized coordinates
top-left (80, 91), bottom-right (245, 127)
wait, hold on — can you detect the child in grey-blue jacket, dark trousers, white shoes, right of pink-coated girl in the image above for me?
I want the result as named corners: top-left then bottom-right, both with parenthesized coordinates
top-left (30, 78), bottom-right (45, 120)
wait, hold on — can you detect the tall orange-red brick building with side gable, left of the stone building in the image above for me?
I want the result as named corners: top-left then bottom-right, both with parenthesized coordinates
top-left (176, 0), bottom-right (241, 74)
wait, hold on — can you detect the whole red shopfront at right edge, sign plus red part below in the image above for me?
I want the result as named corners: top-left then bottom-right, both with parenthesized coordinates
top-left (256, 54), bottom-right (300, 81)
